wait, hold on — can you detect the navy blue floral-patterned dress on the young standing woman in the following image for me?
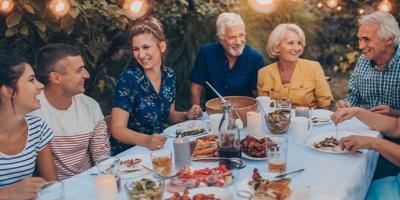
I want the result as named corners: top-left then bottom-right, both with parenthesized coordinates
top-left (111, 65), bottom-right (176, 155)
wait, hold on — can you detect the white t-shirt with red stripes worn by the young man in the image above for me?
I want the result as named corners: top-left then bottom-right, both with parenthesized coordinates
top-left (32, 92), bottom-right (110, 179)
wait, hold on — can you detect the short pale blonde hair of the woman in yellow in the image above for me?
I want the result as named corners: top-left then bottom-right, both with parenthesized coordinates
top-left (266, 24), bottom-right (306, 58)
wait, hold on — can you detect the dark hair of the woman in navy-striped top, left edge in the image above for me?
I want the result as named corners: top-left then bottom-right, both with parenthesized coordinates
top-left (0, 54), bottom-right (26, 107)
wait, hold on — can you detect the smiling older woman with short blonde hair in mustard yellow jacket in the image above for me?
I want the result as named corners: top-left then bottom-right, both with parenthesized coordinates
top-left (257, 24), bottom-right (333, 109)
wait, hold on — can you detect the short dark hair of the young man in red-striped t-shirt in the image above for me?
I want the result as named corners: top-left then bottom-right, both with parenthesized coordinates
top-left (35, 43), bottom-right (81, 85)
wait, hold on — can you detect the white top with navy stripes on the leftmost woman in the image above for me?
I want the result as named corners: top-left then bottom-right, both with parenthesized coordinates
top-left (0, 115), bottom-right (54, 188)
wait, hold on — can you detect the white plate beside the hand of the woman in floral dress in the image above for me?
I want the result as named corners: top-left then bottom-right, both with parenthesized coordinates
top-left (163, 120), bottom-right (207, 138)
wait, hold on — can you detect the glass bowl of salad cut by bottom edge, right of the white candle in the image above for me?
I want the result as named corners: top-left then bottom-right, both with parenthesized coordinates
top-left (125, 178), bottom-right (164, 200)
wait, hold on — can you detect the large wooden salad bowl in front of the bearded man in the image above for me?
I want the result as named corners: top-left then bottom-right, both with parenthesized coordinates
top-left (206, 96), bottom-right (257, 127)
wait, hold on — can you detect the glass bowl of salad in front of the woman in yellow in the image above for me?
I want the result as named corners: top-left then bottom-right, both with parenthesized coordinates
top-left (264, 110), bottom-right (290, 134)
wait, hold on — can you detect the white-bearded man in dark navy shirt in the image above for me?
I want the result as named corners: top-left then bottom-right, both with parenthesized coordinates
top-left (189, 12), bottom-right (265, 105)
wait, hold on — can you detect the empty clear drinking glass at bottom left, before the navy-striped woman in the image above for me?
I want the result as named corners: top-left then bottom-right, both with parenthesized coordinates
top-left (38, 181), bottom-right (64, 200)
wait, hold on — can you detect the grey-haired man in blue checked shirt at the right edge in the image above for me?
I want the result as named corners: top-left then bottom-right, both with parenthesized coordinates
top-left (335, 11), bottom-right (400, 179)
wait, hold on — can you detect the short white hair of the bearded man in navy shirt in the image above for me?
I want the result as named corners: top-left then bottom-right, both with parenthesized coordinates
top-left (216, 12), bottom-right (244, 38)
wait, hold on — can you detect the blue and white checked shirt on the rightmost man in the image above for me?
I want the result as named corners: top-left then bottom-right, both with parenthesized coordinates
top-left (346, 47), bottom-right (400, 109)
